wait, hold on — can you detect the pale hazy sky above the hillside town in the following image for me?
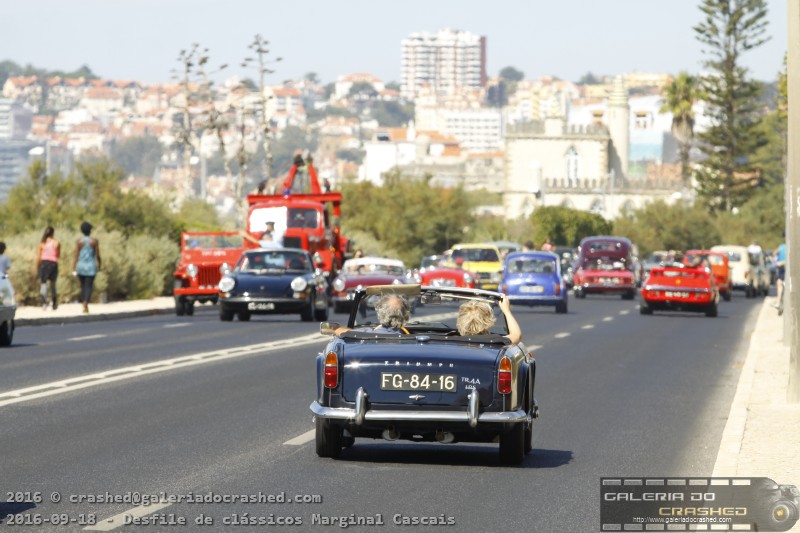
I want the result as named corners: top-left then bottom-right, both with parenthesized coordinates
top-left (0, 0), bottom-right (787, 83)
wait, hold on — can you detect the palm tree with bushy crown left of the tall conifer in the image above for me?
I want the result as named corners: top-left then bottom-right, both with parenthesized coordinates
top-left (661, 72), bottom-right (700, 186)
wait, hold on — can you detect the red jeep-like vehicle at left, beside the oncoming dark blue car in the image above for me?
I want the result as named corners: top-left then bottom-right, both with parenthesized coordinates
top-left (172, 231), bottom-right (245, 316)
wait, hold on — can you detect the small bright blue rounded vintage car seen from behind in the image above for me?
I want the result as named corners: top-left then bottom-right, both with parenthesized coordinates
top-left (500, 252), bottom-right (567, 313)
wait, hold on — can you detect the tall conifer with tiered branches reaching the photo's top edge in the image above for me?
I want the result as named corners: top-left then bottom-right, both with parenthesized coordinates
top-left (693, 0), bottom-right (768, 211)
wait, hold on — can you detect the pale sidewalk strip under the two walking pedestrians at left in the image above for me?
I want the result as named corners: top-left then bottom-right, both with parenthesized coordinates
top-left (14, 296), bottom-right (175, 327)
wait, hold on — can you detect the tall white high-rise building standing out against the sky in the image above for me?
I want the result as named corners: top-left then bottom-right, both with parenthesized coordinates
top-left (401, 29), bottom-right (486, 100)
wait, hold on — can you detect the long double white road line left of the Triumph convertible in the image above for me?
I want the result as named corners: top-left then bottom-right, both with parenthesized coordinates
top-left (0, 333), bottom-right (325, 407)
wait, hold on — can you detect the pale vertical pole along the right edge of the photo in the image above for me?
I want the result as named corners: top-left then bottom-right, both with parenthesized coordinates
top-left (783, 1), bottom-right (800, 403)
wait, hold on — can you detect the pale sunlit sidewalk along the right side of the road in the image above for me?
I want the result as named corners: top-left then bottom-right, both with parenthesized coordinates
top-left (713, 297), bottom-right (800, 531)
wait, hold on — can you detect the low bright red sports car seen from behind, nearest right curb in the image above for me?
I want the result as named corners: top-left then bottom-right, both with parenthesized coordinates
top-left (639, 263), bottom-right (719, 317)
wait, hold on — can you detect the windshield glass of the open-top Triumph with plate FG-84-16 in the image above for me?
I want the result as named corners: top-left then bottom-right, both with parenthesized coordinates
top-left (353, 290), bottom-right (508, 335)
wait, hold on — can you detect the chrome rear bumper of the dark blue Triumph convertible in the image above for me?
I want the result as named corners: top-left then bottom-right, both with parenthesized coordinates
top-left (310, 388), bottom-right (529, 428)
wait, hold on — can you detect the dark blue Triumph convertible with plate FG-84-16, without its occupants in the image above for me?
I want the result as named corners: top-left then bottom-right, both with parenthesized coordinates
top-left (311, 285), bottom-right (539, 464)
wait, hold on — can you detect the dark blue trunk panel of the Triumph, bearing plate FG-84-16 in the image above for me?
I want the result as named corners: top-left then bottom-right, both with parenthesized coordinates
top-left (342, 339), bottom-right (502, 408)
